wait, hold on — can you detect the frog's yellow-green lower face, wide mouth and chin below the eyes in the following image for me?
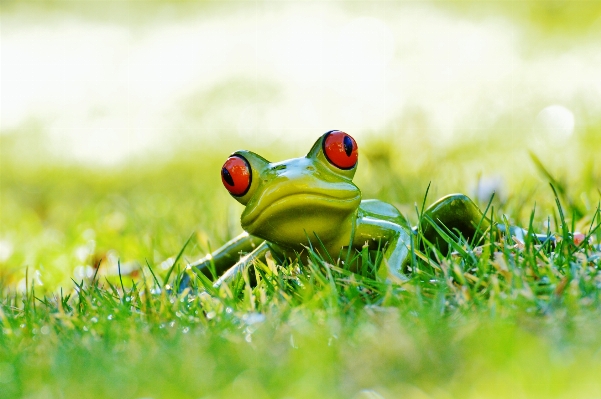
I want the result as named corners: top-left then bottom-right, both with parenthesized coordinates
top-left (241, 193), bottom-right (361, 247)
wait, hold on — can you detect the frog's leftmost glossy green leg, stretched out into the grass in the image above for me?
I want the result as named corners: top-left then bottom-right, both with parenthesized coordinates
top-left (179, 232), bottom-right (264, 291)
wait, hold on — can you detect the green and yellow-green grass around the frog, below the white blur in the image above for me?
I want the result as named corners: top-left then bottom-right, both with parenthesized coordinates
top-left (0, 130), bottom-right (601, 398)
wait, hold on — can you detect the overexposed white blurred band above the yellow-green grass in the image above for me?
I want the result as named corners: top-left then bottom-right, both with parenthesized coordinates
top-left (0, 2), bottom-right (601, 164)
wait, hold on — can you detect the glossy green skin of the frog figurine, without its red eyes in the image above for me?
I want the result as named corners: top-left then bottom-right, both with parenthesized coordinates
top-left (182, 134), bottom-right (490, 287)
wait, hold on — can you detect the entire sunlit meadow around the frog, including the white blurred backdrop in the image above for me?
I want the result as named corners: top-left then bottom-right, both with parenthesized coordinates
top-left (0, 0), bottom-right (601, 399)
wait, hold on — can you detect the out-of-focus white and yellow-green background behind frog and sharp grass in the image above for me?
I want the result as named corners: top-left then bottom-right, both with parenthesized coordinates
top-left (0, 0), bottom-right (601, 289)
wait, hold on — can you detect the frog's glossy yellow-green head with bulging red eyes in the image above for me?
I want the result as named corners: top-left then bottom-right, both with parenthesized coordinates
top-left (221, 130), bottom-right (361, 246)
